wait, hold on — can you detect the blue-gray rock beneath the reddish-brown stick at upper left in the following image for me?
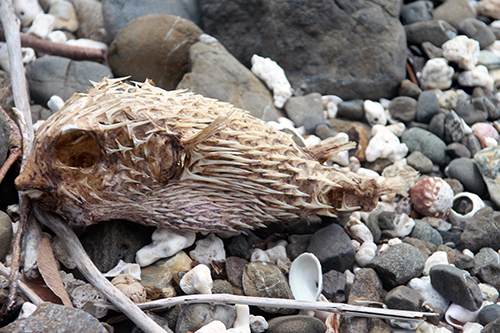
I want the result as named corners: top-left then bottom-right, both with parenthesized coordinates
top-left (26, 55), bottom-right (112, 105)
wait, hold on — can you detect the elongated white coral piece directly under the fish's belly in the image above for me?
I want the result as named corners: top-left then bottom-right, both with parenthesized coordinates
top-left (135, 228), bottom-right (196, 267)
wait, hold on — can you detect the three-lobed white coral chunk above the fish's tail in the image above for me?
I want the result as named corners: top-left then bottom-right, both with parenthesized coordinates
top-left (365, 125), bottom-right (408, 162)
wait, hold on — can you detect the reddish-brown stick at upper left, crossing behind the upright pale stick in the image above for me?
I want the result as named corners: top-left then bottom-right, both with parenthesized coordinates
top-left (0, 28), bottom-right (106, 60)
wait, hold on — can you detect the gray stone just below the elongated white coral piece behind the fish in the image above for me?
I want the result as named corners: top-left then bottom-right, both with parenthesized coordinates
top-left (284, 93), bottom-right (324, 127)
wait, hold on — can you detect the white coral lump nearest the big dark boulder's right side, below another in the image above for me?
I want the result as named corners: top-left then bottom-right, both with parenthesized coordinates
top-left (441, 35), bottom-right (479, 71)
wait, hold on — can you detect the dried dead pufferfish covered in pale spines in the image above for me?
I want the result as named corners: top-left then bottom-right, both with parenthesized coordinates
top-left (16, 78), bottom-right (414, 232)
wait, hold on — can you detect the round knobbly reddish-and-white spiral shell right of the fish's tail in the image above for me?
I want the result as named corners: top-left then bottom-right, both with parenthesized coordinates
top-left (410, 177), bottom-right (453, 217)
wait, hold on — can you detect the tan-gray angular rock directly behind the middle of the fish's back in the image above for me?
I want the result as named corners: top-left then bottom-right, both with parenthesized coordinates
top-left (177, 35), bottom-right (278, 121)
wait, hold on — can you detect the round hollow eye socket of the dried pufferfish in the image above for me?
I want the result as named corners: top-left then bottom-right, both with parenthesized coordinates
top-left (55, 129), bottom-right (100, 168)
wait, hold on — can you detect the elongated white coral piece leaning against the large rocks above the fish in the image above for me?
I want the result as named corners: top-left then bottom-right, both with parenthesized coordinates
top-left (251, 54), bottom-right (292, 108)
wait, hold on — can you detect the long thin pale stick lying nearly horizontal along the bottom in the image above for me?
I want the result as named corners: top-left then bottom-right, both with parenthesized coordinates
top-left (96, 294), bottom-right (438, 320)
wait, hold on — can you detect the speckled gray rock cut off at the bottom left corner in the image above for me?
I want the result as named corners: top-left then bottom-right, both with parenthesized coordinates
top-left (0, 302), bottom-right (108, 333)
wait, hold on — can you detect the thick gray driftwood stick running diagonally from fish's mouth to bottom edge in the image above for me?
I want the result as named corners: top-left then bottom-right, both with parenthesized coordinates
top-left (33, 205), bottom-right (170, 333)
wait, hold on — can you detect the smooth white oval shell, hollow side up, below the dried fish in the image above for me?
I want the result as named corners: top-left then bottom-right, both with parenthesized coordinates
top-left (288, 252), bottom-right (323, 302)
